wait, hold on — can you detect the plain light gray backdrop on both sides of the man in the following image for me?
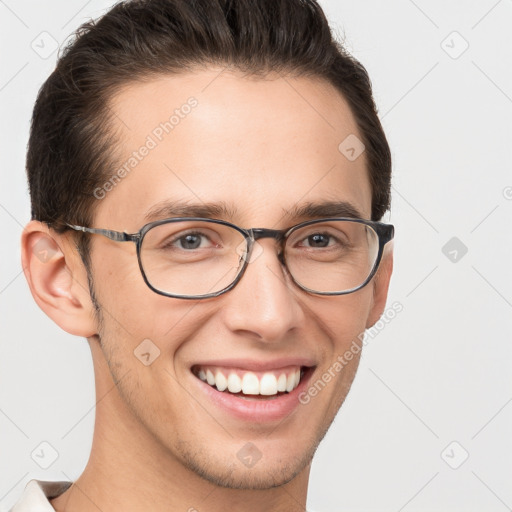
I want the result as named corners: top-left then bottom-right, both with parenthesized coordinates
top-left (0, 0), bottom-right (512, 512)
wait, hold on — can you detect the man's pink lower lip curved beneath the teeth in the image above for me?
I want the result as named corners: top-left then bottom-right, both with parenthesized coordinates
top-left (192, 368), bottom-right (314, 423)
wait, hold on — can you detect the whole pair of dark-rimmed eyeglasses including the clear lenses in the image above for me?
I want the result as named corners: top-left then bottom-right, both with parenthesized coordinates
top-left (67, 217), bottom-right (394, 299)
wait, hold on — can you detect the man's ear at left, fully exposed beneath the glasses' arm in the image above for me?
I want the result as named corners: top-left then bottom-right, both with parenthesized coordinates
top-left (21, 220), bottom-right (98, 337)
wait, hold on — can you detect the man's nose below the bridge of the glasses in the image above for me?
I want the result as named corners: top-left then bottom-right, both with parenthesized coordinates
top-left (221, 239), bottom-right (305, 342)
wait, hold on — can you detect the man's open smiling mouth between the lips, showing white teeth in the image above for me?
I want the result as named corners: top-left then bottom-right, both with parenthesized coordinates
top-left (191, 365), bottom-right (314, 400)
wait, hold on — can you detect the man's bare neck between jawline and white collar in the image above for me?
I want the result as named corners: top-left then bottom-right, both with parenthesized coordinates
top-left (51, 342), bottom-right (310, 512)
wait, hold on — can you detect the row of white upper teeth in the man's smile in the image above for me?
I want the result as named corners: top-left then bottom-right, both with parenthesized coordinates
top-left (197, 367), bottom-right (301, 396)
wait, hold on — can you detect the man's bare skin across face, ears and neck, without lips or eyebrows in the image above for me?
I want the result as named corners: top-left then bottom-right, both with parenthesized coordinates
top-left (22, 68), bottom-right (393, 512)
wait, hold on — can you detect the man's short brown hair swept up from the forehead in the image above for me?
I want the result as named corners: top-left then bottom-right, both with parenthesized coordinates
top-left (27, 0), bottom-right (391, 252)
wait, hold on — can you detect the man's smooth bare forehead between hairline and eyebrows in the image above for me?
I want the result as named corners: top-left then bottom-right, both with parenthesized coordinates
top-left (96, 68), bottom-right (371, 229)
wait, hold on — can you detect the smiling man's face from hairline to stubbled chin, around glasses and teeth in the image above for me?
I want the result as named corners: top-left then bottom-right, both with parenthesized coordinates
top-left (85, 69), bottom-right (388, 488)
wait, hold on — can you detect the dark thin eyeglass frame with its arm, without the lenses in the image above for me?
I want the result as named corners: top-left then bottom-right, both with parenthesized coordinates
top-left (65, 217), bottom-right (395, 300)
